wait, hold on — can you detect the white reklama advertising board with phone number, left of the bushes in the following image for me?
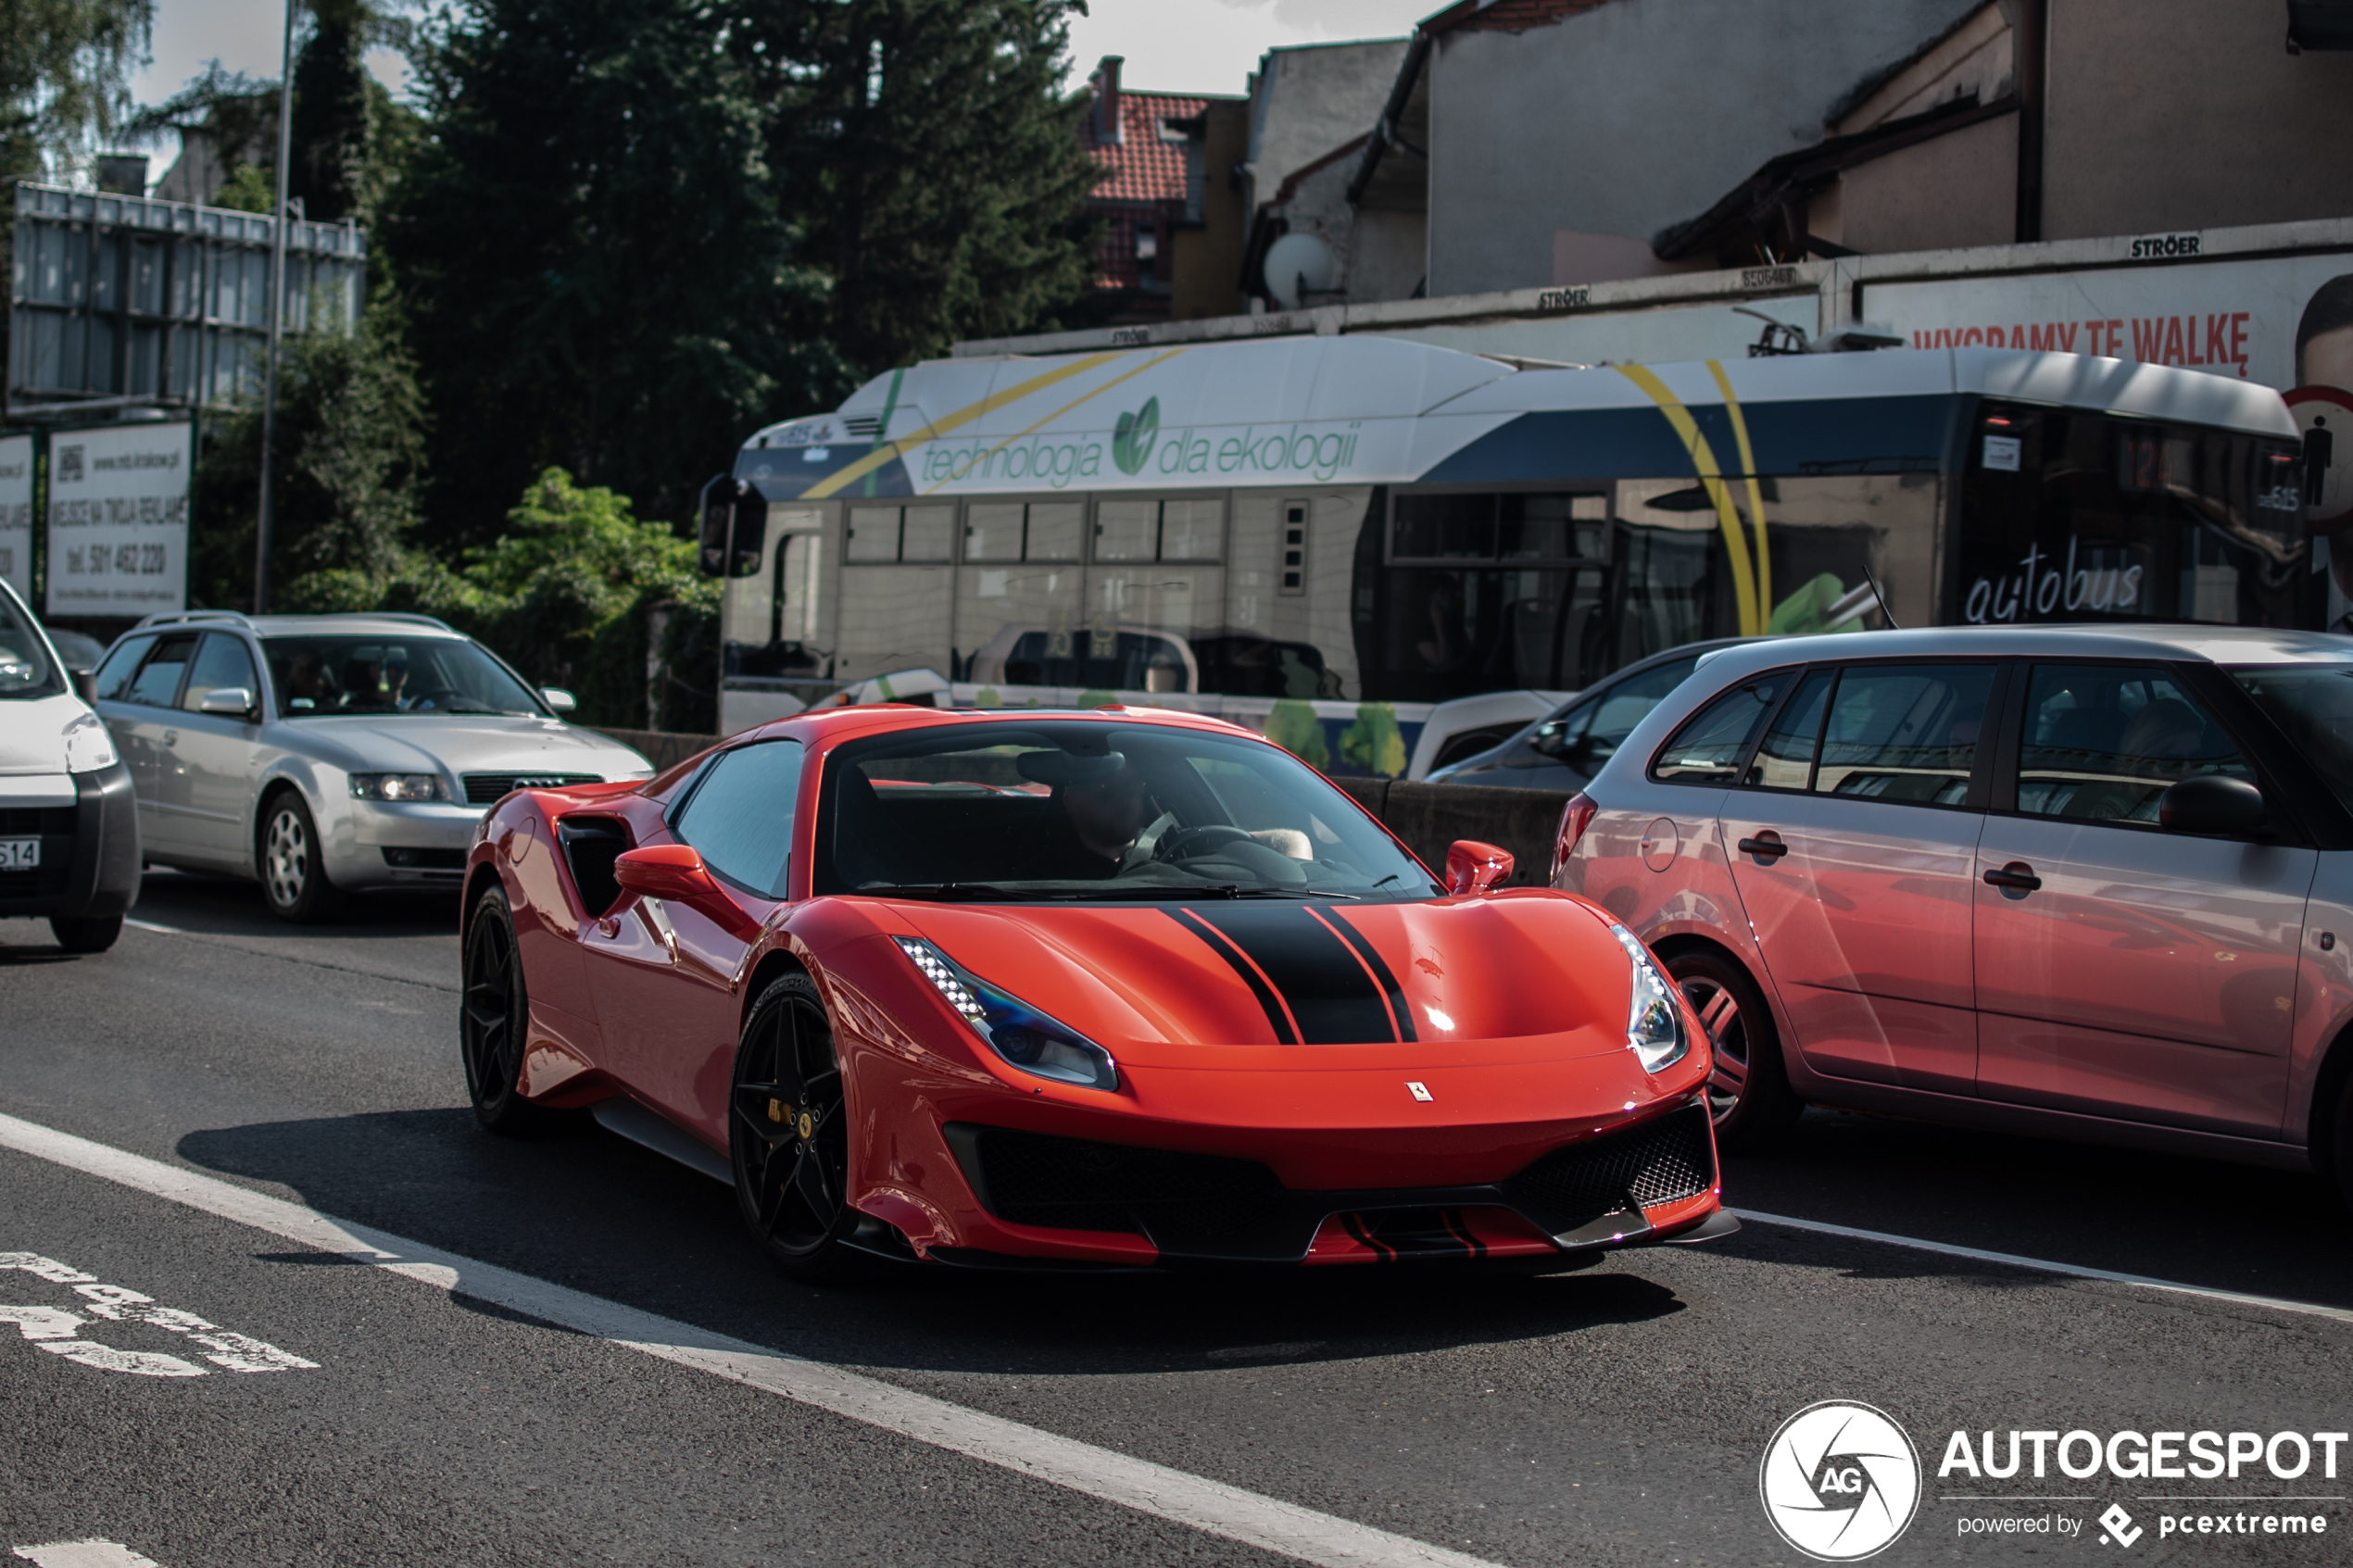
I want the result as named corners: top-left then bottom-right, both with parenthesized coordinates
top-left (47, 420), bottom-right (193, 616)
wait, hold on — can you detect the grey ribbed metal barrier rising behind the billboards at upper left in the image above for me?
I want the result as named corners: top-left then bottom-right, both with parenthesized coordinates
top-left (7, 181), bottom-right (367, 416)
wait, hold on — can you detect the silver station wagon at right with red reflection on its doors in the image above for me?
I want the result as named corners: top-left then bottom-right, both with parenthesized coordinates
top-left (1553, 625), bottom-right (2353, 1189)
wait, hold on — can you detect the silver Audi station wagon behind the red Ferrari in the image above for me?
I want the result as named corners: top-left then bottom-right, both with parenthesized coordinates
top-left (96, 611), bottom-right (654, 922)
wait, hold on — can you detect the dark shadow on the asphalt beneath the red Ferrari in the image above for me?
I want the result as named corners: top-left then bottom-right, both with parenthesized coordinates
top-left (177, 1110), bottom-right (1682, 1373)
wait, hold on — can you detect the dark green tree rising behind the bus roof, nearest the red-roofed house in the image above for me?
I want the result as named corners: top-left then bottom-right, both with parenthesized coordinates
top-left (727, 0), bottom-right (1097, 374)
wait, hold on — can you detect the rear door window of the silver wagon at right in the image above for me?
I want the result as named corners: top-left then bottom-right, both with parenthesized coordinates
top-left (1814, 665), bottom-right (1993, 807)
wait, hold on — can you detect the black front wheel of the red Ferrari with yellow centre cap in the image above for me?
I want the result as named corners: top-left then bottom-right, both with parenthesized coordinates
top-left (727, 973), bottom-right (868, 1284)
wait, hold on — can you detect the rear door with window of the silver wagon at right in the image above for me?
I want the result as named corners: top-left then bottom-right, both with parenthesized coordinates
top-left (1722, 660), bottom-right (2000, 1096)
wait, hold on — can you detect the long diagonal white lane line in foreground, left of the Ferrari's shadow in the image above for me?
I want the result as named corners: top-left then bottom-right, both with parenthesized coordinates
top-left (0, 1117), bottom-right (1496, 1568)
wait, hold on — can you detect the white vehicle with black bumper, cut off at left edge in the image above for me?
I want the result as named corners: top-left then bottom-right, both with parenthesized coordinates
top-left (0, 581), bottom-right (139, 952)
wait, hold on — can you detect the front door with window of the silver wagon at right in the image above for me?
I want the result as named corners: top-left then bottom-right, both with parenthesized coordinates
top-left (1972, 663), bottom-right (2318, 1138)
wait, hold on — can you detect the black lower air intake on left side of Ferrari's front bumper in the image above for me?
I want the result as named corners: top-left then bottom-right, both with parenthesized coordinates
top-left (976, 1128), bottom-right (1282, 1236)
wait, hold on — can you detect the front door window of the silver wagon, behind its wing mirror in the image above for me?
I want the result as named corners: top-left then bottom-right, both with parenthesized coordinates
top-left (2019, 665), bottom-right (2254, 827)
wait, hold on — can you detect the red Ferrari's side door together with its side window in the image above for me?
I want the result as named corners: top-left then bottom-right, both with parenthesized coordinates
top-left (581, 741), bottom-right (802, 1138)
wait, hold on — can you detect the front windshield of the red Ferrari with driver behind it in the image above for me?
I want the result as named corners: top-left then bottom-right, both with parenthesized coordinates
top-left (814, 720), bottom-right (1438, 903)
